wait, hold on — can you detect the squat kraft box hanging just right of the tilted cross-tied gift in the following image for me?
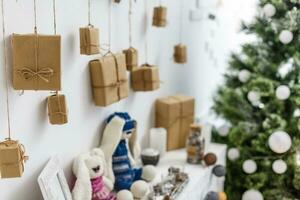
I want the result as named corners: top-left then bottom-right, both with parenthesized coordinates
top-left (131, 64), bottom-right (160, 91)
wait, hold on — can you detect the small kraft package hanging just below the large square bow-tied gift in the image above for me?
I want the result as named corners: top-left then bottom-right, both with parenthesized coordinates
top-left (47, 94), bottom-right (68, 124)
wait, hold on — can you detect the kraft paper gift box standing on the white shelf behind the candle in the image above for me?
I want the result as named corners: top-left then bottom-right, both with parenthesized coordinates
top-left (155, 95), bottom-right (195, 150)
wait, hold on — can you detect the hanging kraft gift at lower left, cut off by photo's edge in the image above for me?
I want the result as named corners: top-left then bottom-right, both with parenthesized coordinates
top-left (0, 140), bottom-right (28, 178)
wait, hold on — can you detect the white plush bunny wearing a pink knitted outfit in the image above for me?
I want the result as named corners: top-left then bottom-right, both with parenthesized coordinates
top-left (72, 148), bottom-right (116, 200)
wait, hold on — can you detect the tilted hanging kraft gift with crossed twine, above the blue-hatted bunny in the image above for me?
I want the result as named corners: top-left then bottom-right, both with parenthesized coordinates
top-left (90, 53), bottom-right (129, 106)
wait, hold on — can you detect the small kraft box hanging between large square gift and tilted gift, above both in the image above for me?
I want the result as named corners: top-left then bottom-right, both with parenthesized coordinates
top-left (79, 26), bottom-right (100, 55)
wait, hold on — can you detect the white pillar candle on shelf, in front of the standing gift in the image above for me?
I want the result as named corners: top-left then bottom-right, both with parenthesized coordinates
top-left (150, 128), bottom-right (167, 156)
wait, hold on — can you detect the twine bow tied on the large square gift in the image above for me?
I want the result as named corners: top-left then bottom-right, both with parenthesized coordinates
top-left (18, 67), bottom-right (54, 83)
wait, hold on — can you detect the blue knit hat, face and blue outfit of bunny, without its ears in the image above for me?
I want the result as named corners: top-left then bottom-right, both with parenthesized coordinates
top-left (107, 112), bottom-right (143, 191)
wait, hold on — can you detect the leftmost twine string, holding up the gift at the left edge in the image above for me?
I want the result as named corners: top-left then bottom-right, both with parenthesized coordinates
top-left (1, 0), bottom-right (11, 140)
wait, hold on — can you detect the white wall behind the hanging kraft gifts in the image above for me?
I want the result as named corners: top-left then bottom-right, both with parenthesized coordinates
top-left (0, 0), bottom-right (254, 200)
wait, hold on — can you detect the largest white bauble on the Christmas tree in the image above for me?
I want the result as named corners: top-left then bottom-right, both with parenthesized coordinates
top-left (268, 131), bottom-right (292, 154)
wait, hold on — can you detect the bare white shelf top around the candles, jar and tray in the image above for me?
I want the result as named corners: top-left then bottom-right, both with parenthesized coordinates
top-left (152, 143), bottom-right (227, 200)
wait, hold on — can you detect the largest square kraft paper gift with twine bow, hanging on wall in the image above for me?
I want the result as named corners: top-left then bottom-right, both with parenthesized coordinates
top-left (12, 34), bottom-right (61, 91)
